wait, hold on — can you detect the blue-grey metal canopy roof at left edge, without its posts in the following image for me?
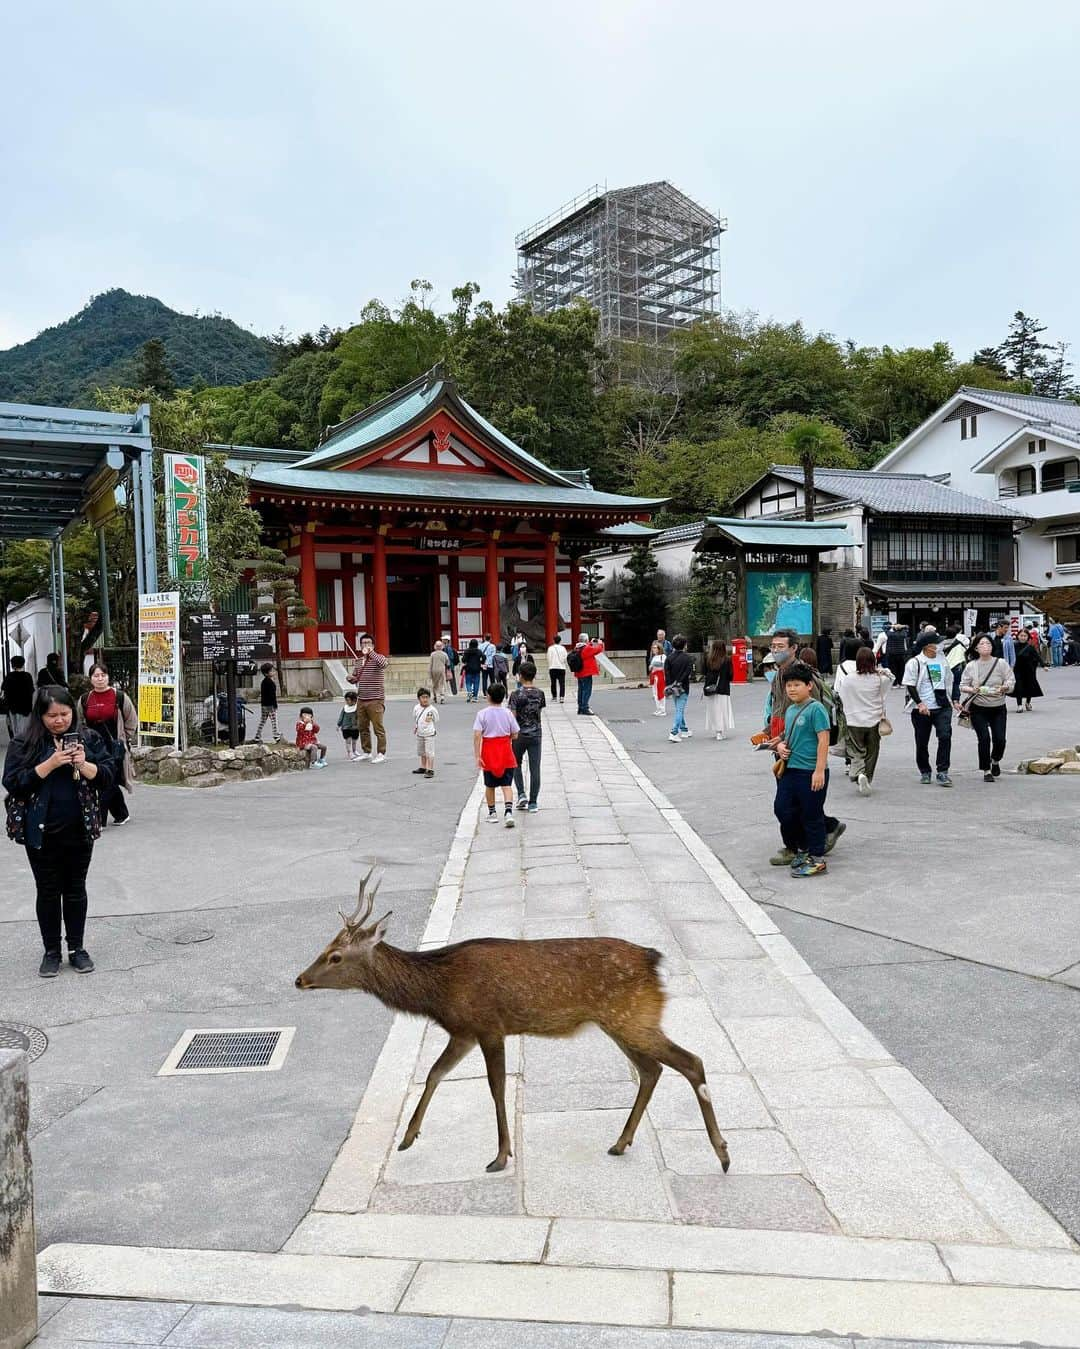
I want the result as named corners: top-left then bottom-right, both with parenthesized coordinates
top-left (0, 403), bottom-right (151, 540)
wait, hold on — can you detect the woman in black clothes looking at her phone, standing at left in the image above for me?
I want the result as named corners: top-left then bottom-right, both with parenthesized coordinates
top-left (4, 685), bottom-right (115, 979)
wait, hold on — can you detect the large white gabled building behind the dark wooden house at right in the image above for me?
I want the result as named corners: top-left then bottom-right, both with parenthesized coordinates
top-left (876, 386), bottom-right (1080, 616)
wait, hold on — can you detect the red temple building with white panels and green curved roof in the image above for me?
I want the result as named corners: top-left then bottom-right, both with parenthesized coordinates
top-left (222, 367), bottom-right (663, 660)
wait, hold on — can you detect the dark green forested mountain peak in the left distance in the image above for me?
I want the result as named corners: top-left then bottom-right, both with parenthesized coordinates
top-left (0, 290), bottom-right (271, 406)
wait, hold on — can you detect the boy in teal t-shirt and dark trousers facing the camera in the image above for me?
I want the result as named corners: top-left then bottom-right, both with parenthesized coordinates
top-left (773, 661), bottom-right (829, 877)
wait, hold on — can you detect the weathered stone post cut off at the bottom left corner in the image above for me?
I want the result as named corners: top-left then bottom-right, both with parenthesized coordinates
top-left (0, 1050), bottom-right (38, 1349)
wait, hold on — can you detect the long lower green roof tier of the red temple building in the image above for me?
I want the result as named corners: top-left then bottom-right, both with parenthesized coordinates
top-left (228, 459), bottom-right (665, 514)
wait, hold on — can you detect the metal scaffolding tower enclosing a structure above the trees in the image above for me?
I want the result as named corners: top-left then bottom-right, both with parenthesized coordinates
top-left (515, 182), bottom-right (727, 376)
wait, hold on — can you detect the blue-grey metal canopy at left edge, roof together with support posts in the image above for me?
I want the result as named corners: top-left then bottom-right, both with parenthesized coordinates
top-left (0, 403), bottom-right (158, 671)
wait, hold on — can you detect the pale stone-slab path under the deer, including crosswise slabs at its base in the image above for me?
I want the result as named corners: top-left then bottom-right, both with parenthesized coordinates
top-left (40, 708), bottom-right (1080, 1346)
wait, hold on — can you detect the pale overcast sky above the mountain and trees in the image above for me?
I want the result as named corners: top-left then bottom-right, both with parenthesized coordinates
top-left (0, 0), bottom-right (1080, 363)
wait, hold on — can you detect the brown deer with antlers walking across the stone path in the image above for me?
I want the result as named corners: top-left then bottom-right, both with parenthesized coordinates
top-left (297, 867), bottom-right (729, 1172)
